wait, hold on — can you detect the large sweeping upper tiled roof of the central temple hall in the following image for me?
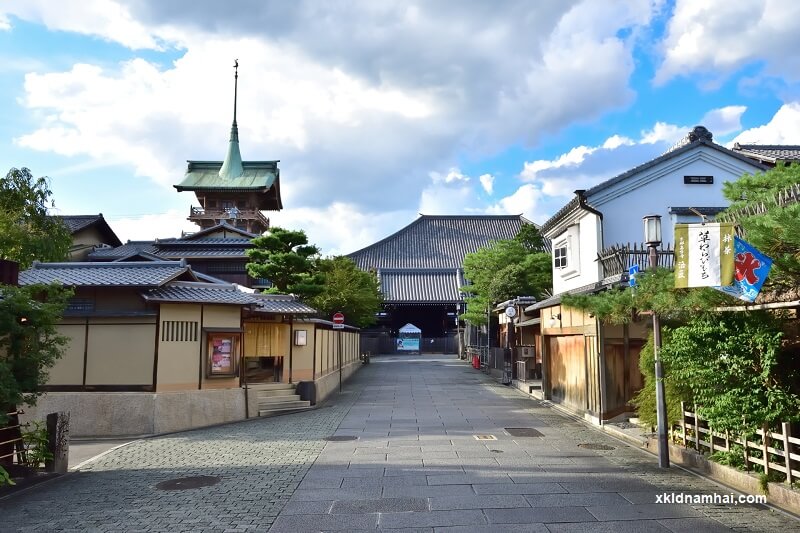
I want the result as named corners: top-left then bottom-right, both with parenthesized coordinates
top-left (348, 215), bottom-right (530, 270)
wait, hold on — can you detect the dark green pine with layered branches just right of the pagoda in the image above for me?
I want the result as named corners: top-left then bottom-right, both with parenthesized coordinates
top-left (247, 227), bottom-right (322, 299)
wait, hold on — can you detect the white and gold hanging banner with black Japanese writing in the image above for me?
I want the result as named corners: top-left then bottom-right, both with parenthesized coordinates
top-left (675, 223), bottom-right (735, 289)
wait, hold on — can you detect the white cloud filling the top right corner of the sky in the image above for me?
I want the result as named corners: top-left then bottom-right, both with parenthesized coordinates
top-left (655, 0), bottom-right (800, 84)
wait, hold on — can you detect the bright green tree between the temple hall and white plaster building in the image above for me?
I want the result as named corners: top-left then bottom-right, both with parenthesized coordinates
top-left (461, 224), bottom-right (553, 325)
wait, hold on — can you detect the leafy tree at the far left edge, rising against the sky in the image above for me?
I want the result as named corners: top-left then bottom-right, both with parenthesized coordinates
top-left (0, 168), bottom-right (72, 269)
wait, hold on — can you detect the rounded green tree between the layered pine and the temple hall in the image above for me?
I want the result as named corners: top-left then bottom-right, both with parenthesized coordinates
top-left (309, 256), bottom-right (383, 327)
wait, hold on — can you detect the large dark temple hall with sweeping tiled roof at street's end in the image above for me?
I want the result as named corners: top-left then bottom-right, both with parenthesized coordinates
top-left (348, 215), bottom-right (532, 351)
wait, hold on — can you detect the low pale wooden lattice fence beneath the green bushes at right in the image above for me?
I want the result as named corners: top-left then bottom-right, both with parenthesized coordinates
top-left (673, 402), bottom-right (800, 485)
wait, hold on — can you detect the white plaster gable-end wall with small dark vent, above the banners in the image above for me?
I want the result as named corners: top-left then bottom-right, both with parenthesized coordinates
top-left (587, 146), bottom-right (757, 247)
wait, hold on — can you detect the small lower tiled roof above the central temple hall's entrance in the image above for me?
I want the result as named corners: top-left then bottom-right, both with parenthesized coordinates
top-left (378, 268), bottom-right (465, 303)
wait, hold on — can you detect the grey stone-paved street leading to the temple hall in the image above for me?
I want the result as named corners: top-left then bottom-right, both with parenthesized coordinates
top-left (0, 356), bottom-right (800, 533)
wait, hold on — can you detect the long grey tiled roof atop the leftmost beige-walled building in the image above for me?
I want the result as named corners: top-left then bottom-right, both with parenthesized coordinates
top-left (19, 261), bottom-right (194, 287)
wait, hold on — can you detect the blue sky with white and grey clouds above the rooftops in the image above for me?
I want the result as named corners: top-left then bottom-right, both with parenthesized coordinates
top-left (0, 0), bottom-right (800, 254)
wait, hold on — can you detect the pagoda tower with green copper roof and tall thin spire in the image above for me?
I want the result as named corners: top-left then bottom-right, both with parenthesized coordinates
top-left (174, 60), bottom-right (283, 235)
